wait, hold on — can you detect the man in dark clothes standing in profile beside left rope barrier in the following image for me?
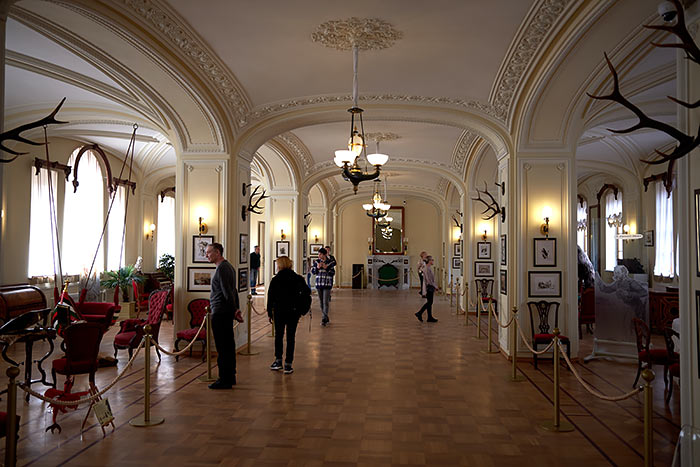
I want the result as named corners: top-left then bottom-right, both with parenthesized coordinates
top-left (206, 243), bottom-right (243, 389)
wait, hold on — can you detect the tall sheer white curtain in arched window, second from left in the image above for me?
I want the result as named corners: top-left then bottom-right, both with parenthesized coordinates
top-left (62, 149), bottom-right (105, 274)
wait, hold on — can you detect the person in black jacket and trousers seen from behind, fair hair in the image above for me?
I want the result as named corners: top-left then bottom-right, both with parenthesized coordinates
top-left (267, 256), bottom-right (311, 374)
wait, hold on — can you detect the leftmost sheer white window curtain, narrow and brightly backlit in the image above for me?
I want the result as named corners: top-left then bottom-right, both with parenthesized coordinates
top-left (27, 167), bottom-right (59, 277)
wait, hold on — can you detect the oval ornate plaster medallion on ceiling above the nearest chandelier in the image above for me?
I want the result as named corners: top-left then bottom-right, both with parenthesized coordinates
top-left (311, 16), bottom-right (403, 50)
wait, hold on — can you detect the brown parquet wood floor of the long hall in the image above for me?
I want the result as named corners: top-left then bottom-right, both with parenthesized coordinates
top-left (0, 289), bottom-right (680, 467)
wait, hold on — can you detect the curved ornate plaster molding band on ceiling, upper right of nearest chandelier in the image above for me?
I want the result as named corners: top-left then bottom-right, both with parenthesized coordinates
top-left (489, 0), bottom-right (572, 123)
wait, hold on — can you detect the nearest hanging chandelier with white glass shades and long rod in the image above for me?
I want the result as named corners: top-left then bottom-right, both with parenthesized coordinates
top-left (333, 44), bottom-right (389, 193)
